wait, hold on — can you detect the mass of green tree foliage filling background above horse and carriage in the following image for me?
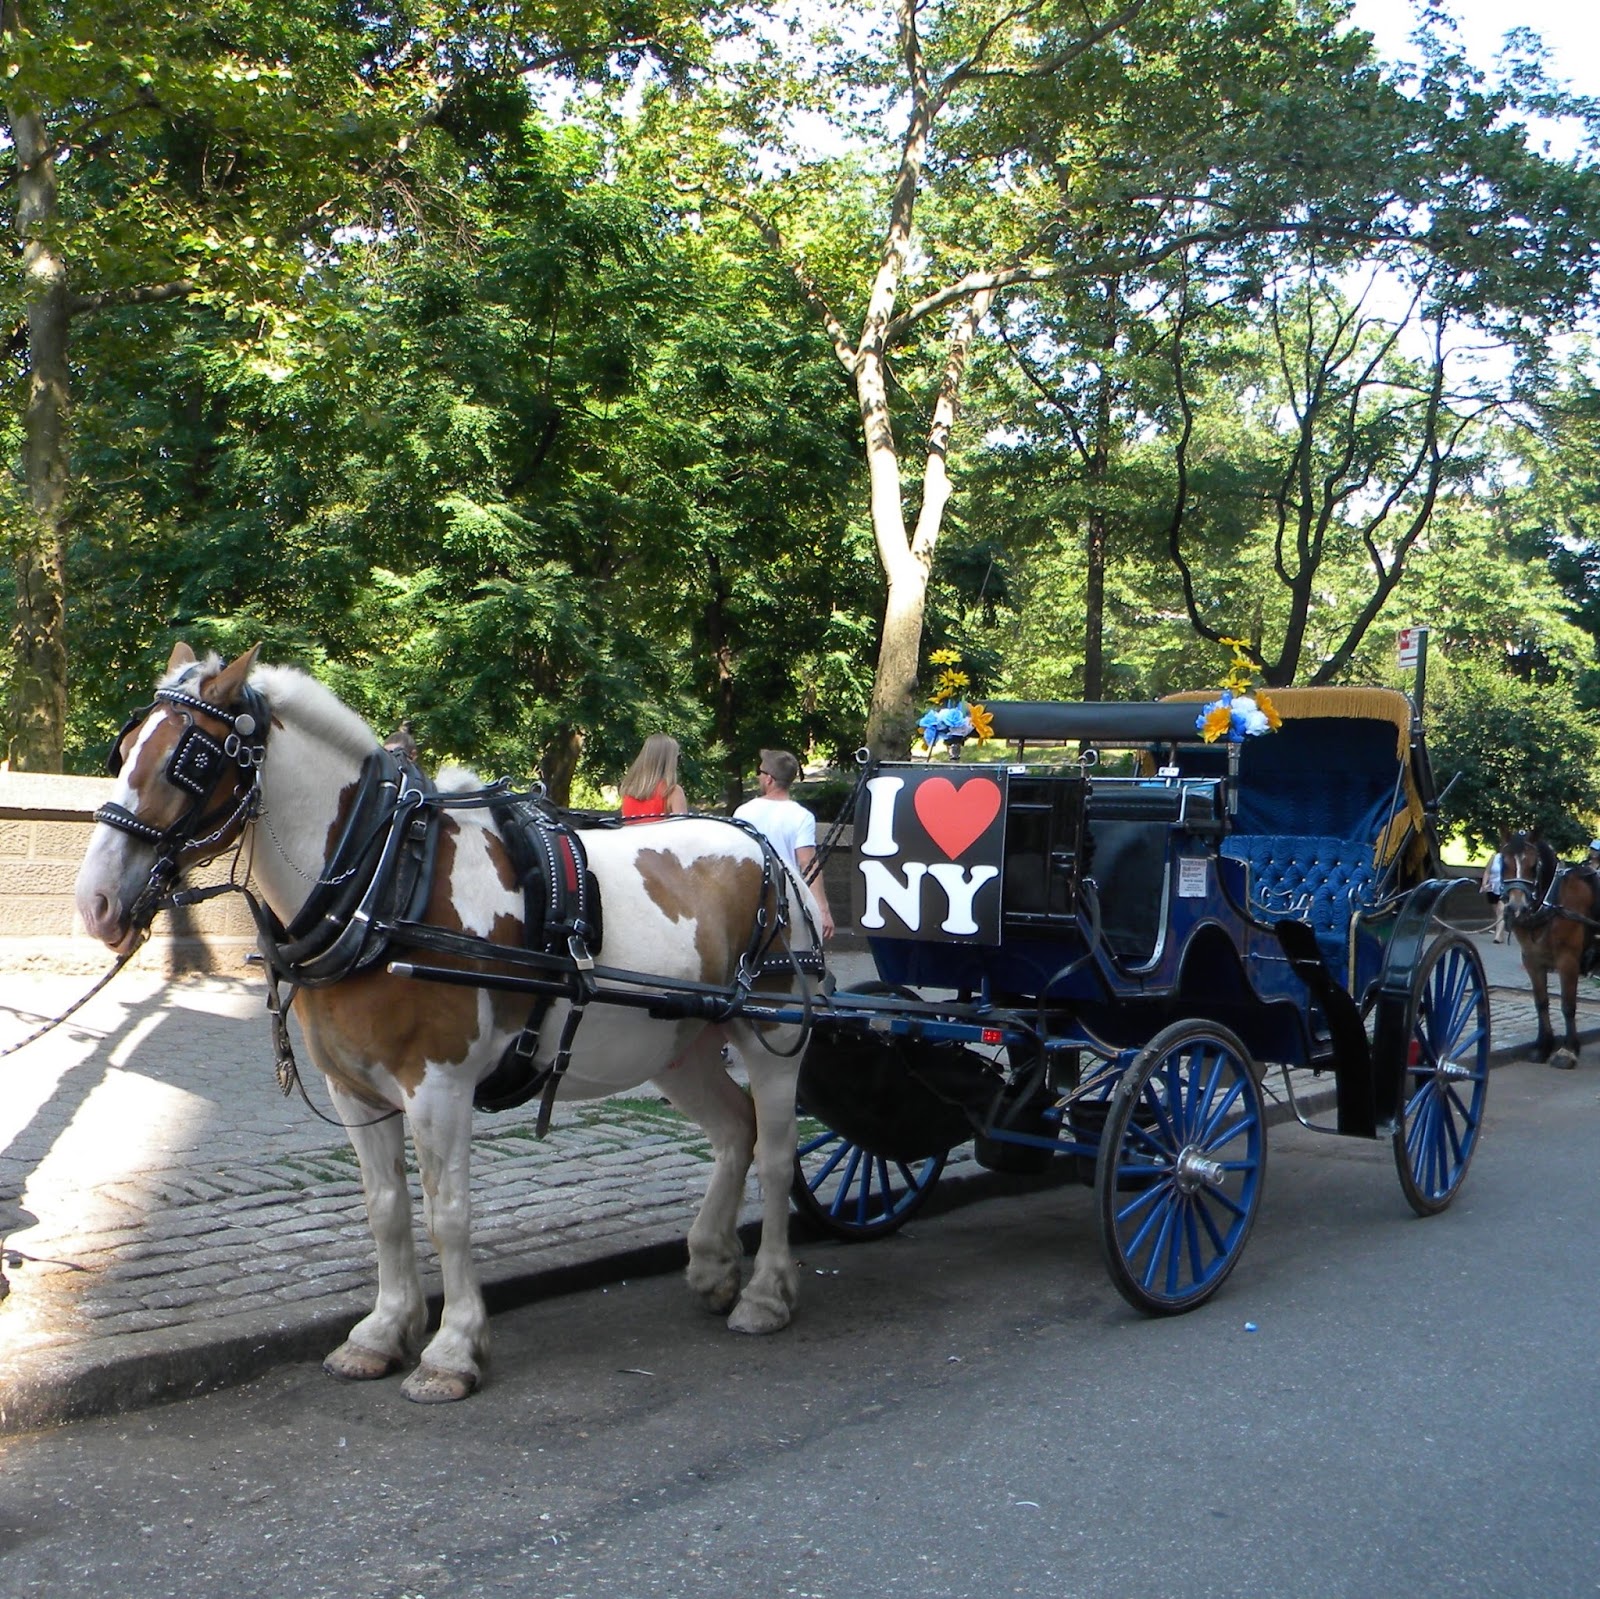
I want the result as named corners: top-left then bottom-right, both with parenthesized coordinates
top-left (9, 0), bottom-right (1600, 806)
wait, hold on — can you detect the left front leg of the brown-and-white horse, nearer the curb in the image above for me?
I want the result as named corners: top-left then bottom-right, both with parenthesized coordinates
top-left (322, 1077), bottom-right (427, 1381)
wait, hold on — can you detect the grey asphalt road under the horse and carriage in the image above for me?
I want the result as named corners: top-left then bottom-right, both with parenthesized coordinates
top-left (0, 1066), bottom-right (1600, 1599)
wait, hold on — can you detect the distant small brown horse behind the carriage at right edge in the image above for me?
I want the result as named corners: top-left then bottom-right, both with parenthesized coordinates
top-left (1501, 832), bottom-right (1600, 1071)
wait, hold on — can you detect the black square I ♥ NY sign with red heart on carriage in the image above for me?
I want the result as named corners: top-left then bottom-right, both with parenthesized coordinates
top-left (854, 767), bottom-right (1006, 944)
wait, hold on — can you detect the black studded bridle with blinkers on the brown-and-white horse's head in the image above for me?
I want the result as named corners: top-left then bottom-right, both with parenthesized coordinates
top-left (94, 685), bottom-right (272, 932)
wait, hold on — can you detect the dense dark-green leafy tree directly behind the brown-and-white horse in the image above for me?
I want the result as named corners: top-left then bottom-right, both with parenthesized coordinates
top-left (62, 101), bottom-right (874, 799)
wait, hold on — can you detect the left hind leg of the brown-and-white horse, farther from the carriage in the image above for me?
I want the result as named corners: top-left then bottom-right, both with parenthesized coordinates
top-left (656, 1028), bottom-right (755, 1316)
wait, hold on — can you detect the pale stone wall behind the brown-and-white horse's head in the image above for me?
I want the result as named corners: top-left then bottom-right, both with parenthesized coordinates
top-left (0, 771), bottom-right (256, 975)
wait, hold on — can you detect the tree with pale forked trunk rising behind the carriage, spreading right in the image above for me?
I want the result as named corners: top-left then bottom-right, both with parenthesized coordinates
top-left (659, 0), bottom-right (1595, 747)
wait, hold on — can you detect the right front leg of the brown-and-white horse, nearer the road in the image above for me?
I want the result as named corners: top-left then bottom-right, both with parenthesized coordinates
top-left (400, 1069), bottom-right (488, 1404)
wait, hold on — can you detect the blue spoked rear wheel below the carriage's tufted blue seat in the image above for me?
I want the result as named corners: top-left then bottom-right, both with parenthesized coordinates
top-left (1394, 933), bottom-right (1490, 1216)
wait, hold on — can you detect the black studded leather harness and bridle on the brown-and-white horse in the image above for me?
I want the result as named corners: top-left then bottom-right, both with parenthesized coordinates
top-left (94, 687), bottom-right (814, 1138)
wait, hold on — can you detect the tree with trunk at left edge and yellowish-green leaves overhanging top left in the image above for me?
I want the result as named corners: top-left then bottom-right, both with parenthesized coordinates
top-left (0, 0), bottom-right (714, 768)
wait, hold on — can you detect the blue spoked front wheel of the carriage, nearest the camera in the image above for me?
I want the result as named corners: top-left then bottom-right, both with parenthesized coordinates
top-left (1094, 1021), bottom-right (1267, 1316)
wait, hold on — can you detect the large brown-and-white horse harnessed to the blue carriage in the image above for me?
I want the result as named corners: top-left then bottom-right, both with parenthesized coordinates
top-left (77, 645), bottom-right (814, 1401)
